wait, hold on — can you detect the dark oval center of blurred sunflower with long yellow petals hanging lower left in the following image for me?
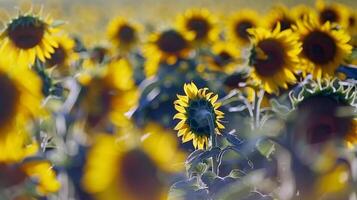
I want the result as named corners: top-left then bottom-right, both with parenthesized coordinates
top-left (157, 30), bottom-right (187, 54)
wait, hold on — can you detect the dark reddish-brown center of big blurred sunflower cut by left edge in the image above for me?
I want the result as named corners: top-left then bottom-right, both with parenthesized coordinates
top-left (0, 73), bottom-right (20, 127)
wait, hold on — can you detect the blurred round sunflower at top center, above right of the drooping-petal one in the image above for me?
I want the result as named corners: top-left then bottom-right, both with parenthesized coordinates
top-left (176, 8), bottom-right (219, 44)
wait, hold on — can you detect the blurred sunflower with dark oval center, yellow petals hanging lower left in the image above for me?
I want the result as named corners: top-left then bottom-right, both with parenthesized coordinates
top-left (144, 29), bottom-right (192, 76)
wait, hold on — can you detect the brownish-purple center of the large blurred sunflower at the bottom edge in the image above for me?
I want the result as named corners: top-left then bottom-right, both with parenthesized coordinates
top-left (119, 149), bottom-right (162, 200)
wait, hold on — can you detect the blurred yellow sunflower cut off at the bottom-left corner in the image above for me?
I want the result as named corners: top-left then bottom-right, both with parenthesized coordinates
top-left (0, 126), bottom-right (60, 195)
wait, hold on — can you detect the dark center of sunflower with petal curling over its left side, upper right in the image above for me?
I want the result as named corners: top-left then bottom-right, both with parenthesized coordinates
top-left (254, 39), bottom-right (285, 76)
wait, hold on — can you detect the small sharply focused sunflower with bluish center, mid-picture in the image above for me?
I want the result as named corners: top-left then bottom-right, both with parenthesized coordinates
top-left (174, 83), bottom-right (224, 149)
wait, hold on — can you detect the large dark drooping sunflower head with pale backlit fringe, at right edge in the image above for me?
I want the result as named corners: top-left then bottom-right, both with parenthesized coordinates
top-left (290, 79), bottom-right (357, 147)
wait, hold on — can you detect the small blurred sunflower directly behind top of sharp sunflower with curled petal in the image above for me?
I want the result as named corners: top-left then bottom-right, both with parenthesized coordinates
top-left (265, 5), bottom-right (296, 31)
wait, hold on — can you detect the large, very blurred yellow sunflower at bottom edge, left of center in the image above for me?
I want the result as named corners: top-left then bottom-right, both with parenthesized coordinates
top-left (82, 128), bottom-right (185, 200)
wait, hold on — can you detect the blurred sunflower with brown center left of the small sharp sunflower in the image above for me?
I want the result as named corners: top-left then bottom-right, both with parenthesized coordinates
top-left (80, 59), bottom-right (139, 128)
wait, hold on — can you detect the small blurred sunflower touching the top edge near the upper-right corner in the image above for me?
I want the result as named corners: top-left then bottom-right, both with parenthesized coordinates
top-left (316, 0), bottom-right (349, 28)
